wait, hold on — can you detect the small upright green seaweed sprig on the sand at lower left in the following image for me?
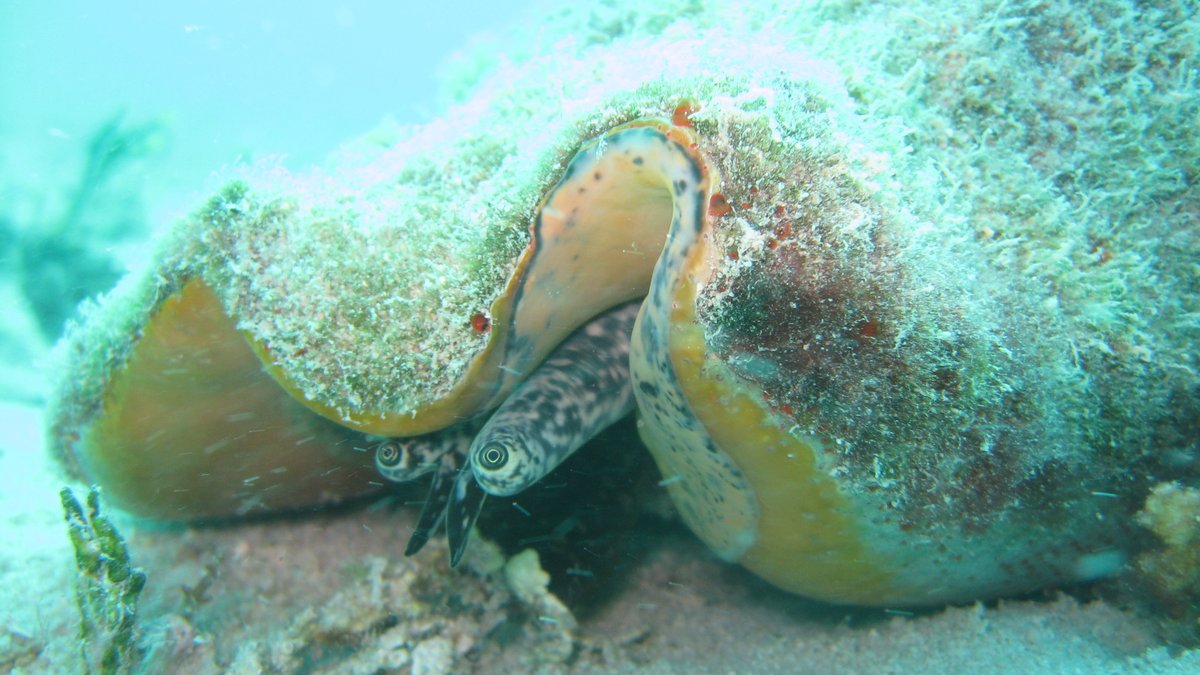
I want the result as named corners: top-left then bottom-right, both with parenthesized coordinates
top-left (59, 486), bottom-right (146, 674)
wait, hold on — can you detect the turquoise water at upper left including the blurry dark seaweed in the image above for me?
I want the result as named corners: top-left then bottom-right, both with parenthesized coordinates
top-left (0, 1), bottom-right (535, 339)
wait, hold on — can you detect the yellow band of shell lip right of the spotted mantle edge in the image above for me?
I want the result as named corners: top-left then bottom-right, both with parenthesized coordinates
top-left (671, 288), bottom-right (910, 604)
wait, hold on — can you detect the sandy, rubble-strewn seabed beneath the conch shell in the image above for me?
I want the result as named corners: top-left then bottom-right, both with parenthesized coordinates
top-left (0, 391), bottom-right (1200, 673)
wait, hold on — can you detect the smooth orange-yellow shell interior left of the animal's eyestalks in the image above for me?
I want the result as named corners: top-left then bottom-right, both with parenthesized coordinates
top-left (72, 280), bottom-right (378, 520)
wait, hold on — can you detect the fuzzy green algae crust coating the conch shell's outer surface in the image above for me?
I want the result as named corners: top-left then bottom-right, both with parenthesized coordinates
top-left (54, 5), bottom-right (1200, 604)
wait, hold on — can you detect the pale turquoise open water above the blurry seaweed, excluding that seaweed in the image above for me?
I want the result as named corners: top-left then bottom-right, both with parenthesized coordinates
top-left (0, 0), bottom-right (522, 223)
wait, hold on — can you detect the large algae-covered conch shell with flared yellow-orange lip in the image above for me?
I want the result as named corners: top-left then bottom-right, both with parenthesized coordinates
top-left (52, 6), bottom-right (1198, 604)
